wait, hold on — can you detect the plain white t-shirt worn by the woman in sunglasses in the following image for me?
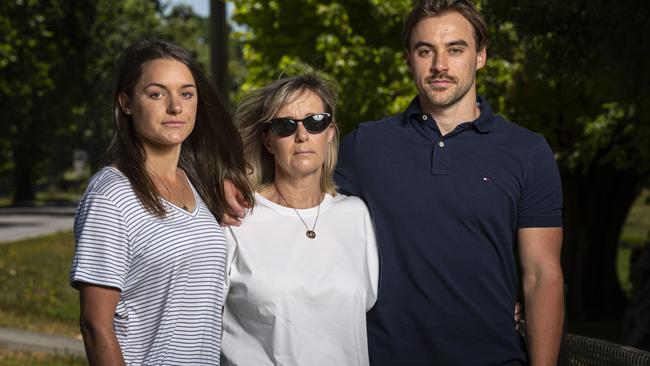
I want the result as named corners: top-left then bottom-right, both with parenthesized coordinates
top-left (222, 194), bottom-right (379, 366)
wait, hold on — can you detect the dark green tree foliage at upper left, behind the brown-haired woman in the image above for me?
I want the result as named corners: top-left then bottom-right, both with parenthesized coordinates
top-left (0, 0), bottom-right (213, 201)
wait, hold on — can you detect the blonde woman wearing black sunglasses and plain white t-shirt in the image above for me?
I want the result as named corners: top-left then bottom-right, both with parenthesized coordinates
top-left (222, 74), bottom-right (378, 366)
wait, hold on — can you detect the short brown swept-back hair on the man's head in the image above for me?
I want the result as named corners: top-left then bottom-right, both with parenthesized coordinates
top-left (402, 0), bottom-right (488, 52)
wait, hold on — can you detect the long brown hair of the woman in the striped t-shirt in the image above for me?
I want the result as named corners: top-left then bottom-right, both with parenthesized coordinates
top-left (107, 39), bottom-right (253, 219)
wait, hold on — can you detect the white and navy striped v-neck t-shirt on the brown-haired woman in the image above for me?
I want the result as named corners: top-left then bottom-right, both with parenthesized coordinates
top-left (70, 167), bottom-right (227, 365)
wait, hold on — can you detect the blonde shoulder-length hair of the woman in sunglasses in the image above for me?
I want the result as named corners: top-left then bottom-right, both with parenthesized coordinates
top-left (234, 73), bottom-right (339, 195)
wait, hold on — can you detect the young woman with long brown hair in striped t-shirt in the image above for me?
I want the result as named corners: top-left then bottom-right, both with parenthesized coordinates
top-left (70, 40), bottom-right (251, 365)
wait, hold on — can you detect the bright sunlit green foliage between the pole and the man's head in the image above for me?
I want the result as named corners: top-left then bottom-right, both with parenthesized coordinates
top-left (234, 0), bottom-right (415, 133)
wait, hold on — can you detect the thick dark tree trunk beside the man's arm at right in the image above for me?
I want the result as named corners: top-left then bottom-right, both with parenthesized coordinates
top-left (562, 166), bottom-right (643, 320)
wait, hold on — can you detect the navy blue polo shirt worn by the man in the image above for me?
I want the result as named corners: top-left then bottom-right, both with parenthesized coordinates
top-left (335, 97), bottom-right (562, 366)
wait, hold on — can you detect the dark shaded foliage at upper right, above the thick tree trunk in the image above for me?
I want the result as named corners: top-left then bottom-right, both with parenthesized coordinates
top-left (483, 0), bottom-right (650, 177)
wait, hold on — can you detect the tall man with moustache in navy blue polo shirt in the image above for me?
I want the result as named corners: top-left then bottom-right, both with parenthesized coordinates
top-left (336, 0), bottom-right (563, 366)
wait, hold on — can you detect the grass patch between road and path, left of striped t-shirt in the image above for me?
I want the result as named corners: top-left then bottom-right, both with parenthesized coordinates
top-left (0, 232), bottom-right (79, 336)
